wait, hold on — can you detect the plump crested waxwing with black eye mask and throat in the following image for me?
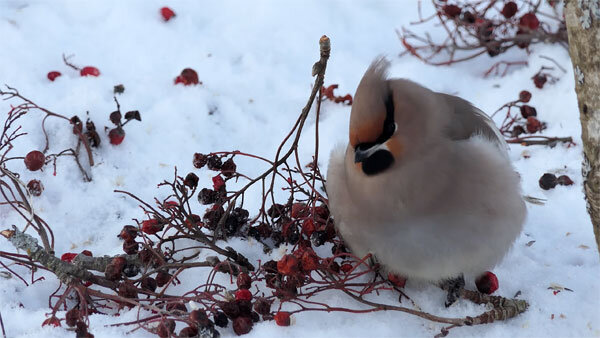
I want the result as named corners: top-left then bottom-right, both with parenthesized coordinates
top-left (325, 57), bottom-right (527, 306)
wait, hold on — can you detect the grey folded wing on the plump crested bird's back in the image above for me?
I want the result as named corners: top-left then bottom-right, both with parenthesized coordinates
top-left (440, 93), bottom-right (508, 153)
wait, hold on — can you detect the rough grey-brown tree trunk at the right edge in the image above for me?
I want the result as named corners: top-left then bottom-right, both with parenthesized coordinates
top-left (565, 0), bottom-right (600, 258)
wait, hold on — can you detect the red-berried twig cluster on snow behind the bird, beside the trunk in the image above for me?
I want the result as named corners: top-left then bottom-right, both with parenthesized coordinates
top-left (396, 0), bottom-right (567, 68)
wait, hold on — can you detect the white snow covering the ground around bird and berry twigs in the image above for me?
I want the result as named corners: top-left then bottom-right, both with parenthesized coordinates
top-left (0, 0), bottom-right (600, 337)
